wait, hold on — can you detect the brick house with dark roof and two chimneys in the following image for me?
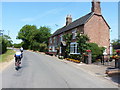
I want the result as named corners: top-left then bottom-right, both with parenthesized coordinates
top-left (49, 0), bottom-right (110, 55)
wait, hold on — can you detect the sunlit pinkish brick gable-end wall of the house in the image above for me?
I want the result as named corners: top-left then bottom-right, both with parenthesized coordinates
top-left (84, 15), bottom-right (110, 54)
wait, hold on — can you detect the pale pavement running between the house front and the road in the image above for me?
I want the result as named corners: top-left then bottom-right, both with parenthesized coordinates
top-left (48, 56), bottom-right (120, 87)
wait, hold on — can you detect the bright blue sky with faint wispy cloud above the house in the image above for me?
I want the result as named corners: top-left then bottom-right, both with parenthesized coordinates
top-left (0, 2), bottom-right (118, 43)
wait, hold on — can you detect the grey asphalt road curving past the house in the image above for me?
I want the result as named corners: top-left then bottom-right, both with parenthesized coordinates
top-left (2, 51), bottom-right (117, 88)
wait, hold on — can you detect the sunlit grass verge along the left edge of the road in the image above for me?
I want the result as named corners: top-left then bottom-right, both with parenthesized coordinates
top-left (0, 49), bottom-right (15, 63)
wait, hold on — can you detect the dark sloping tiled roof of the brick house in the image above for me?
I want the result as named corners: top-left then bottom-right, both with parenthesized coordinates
top-left (51, 12), bottom-right (94, 37)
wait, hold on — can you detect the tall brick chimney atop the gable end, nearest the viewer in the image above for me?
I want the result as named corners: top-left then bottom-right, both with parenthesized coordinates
top-left (91, 0), bottom-right (101, 15)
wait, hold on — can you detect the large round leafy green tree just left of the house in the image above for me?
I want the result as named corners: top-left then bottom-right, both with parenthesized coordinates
top-left (17, 25), bottom-right (51, 50)
